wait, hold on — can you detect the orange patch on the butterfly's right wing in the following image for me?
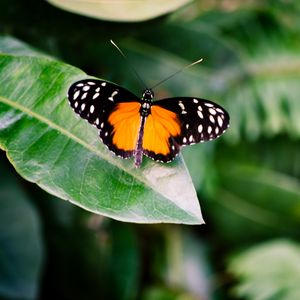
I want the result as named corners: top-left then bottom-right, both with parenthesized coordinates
top-left (143, 105), bottom-right (181, 155)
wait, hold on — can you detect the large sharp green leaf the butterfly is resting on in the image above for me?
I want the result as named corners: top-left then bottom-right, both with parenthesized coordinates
top-left (0, 45), bottom-right (203, 224)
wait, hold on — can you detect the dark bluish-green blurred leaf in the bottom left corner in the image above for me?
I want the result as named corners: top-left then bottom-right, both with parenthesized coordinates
top-left (0, 158), bottom-right (43, 299)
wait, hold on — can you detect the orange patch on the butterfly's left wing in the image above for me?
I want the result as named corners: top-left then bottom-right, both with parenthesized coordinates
top-left (108, 102), bottom-right (141, 151)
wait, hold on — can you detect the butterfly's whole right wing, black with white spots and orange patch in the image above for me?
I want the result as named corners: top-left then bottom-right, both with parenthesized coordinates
top-left (143, 97), bottom-right (229, 162)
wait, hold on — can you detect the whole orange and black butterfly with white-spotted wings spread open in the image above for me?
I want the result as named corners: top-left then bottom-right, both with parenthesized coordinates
top-left (68, 79), bottom-right (229, 167)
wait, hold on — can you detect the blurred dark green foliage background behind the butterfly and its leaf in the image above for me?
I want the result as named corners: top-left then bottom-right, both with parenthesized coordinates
top-left (0, 0), bottom-right (300, 300)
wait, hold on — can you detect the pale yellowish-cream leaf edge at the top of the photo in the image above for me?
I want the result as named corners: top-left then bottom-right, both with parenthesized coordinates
top-left (48, 0), bottom-right (191, 22)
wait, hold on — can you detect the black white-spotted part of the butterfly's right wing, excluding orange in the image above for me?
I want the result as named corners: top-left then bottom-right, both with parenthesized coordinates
top-left (153, 97), bottom-right (230, 147)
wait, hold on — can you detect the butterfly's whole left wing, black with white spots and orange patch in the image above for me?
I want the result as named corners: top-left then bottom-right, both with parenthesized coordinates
top-left (68, 79), bottom-right (141, 158)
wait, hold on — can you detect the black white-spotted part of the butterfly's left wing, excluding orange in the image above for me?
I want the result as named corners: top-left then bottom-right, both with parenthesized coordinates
top-left (68, 79), bottom-right (141, 158)
